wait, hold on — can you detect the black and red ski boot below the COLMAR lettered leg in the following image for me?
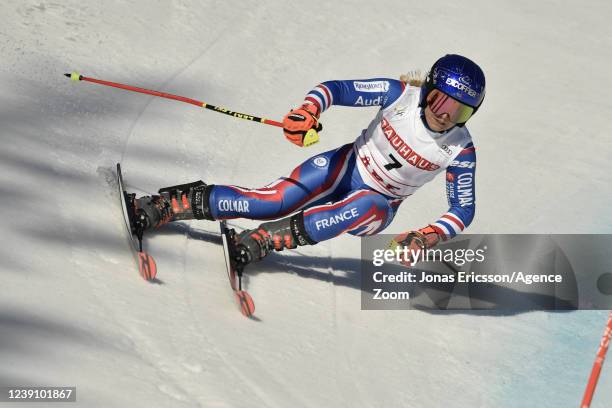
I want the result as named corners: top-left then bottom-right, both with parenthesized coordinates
top-left (134, 181), bottom-right (213, 231)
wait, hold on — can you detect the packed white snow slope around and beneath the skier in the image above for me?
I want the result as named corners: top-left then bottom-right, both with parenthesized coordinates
top-left (0, 0), bottom-right (612, 407)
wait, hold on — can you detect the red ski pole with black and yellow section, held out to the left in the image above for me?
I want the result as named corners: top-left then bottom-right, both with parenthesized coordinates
top-left (64, 72), bottom-right (319, 146)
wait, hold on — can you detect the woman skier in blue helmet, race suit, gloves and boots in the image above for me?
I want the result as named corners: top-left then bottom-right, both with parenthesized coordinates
top-left (135, 55), bottom-right (485, 266)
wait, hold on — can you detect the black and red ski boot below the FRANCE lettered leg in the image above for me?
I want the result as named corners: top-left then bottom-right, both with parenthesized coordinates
top-left (234, 212), bottom-right (316, 268)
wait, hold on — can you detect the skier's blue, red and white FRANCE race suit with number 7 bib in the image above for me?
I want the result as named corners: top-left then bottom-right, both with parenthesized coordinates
top-left (209, 78), bottom-right (476, 242)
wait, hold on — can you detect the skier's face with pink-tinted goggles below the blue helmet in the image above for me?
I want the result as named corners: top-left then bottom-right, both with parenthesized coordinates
top-left (425, 89), bottom-right (474, 132)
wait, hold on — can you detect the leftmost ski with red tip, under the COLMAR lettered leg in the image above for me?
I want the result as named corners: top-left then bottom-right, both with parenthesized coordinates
top-left (117, 163), bottom-right (158, 282)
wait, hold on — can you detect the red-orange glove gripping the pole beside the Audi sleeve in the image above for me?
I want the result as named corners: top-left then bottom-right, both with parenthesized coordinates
top-left (283, 103), bottom-right (323, 146)
